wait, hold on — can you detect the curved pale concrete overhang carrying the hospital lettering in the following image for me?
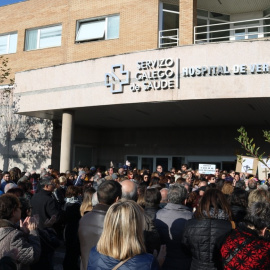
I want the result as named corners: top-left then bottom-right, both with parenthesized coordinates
top-left (15, 40), bottom-right (270, 128)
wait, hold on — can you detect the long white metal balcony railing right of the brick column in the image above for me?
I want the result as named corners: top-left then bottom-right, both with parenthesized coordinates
top-left (194, 17), bottom-right (270, 44)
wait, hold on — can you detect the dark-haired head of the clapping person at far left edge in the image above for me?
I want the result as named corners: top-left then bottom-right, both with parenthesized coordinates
top-left (0, 194), bottom-right (21, 220)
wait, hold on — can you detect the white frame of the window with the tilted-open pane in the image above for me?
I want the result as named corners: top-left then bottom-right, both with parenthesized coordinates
top-left (75, 13), bottom-right (120, 44)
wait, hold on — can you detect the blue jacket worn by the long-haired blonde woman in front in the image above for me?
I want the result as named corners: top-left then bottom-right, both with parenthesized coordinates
top-left (87, 247), bottom-right (160, 270)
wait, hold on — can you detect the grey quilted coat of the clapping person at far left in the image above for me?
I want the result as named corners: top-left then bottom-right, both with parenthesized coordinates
top-left (0, 219), bottom-right (40, 270)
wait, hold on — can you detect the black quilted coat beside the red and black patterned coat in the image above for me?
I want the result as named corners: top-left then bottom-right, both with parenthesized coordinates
top-left (182, 211), bottom-right (232, 270)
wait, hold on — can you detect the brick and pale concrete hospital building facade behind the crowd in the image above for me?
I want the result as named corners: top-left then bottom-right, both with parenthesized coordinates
top-left (0, 0), bottom-right (270, 171)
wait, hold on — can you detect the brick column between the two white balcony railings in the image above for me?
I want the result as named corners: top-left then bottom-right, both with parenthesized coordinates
top-left (179, 0), bottom-right (197, 45)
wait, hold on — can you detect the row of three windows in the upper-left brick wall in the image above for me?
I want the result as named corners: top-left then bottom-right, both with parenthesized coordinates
top-left (0, 15), bottom-right (120, 55)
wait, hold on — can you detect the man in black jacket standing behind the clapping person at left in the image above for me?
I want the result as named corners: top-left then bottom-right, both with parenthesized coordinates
top-left (31, 176), bottom-right (61, 229)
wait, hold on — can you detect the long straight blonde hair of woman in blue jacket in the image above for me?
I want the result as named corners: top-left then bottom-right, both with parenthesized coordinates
top-left (97, 200), bottom-right (146, 260)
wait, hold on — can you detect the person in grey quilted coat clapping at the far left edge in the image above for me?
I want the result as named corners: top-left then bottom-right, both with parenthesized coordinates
top-left (0, 194), bottom-right (40, 270)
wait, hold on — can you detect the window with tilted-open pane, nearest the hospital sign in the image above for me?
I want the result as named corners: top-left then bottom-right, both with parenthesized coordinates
top-left (76, 15), bottom-right (120, 42)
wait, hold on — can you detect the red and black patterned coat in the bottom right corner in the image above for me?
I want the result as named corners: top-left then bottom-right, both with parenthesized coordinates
top-left (220, 223), bottom-right (270, 270)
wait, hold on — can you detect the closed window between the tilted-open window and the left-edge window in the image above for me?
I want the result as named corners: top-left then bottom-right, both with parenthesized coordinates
top-left (25, 25), bottom-right (62, 51)
